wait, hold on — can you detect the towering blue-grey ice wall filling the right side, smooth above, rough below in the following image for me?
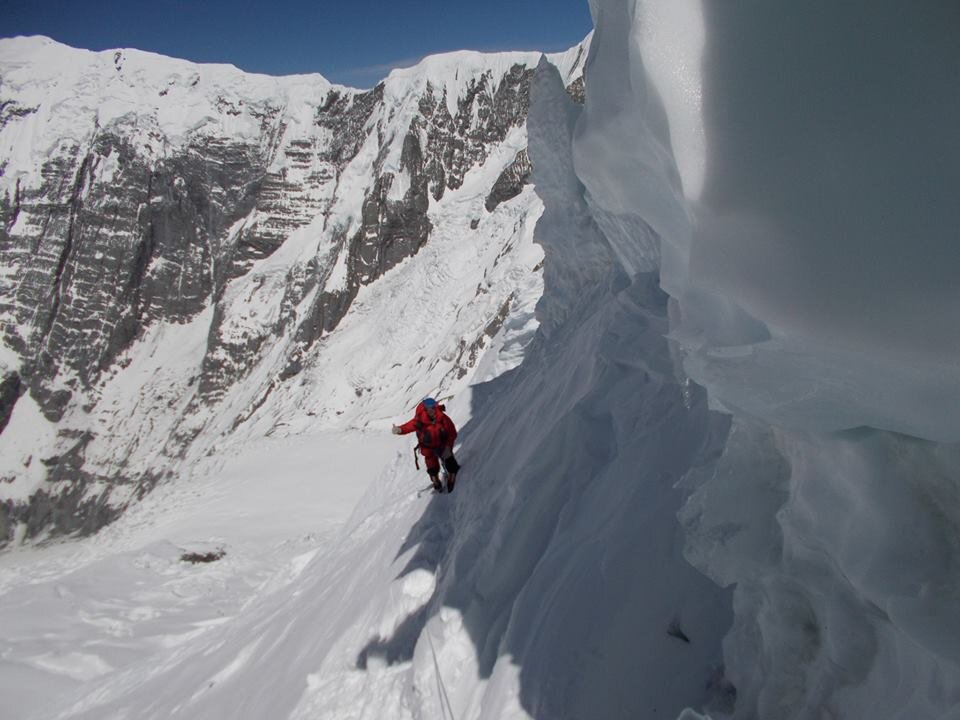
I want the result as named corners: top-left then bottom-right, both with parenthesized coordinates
top-left (574, 0), bottom-right (960, 718)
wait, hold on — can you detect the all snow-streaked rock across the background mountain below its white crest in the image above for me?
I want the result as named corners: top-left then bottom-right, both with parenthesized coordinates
top-left (0, 42), bottom-right (588, 542)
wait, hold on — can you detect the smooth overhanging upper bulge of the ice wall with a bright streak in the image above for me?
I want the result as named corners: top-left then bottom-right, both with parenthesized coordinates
top-left (575, 2), bottom-right (960, 442)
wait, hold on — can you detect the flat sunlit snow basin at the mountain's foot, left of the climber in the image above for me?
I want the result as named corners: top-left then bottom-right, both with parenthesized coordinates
top-left (0, 431), bottom-right (402, 718)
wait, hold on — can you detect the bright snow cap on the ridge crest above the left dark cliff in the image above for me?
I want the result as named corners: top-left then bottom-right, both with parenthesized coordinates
top-left (0, 37), bottom-right (334, 196)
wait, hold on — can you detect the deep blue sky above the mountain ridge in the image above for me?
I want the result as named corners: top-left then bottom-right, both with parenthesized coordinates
top-left (0, 0), bottom-right (592, 87)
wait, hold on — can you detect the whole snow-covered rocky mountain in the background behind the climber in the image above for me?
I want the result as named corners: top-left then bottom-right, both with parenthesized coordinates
top-left (0, 33), bottom-right (586, 538)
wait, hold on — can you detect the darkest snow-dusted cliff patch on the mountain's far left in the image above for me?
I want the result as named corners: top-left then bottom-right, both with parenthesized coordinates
top-left (0, 128), bottom-right (264, 390)
